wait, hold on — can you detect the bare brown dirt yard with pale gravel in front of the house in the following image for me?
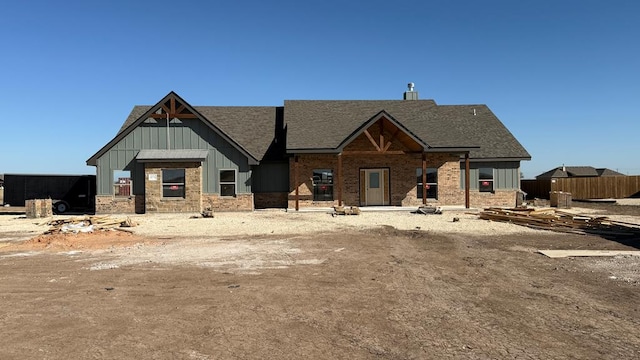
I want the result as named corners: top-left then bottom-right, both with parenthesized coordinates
top-left (0, 204), bottom-right (640, 359)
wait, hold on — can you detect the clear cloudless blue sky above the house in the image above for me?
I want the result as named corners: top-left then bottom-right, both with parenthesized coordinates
top-left (0, 0), bottom-right (640, 178)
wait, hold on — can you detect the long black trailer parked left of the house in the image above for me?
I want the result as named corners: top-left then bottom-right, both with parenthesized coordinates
top-left (4, 174), bottom-right (96, 214)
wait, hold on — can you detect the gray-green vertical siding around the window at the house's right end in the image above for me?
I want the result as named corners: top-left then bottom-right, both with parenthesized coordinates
top-left (460, 161), bottom-right (520, 190)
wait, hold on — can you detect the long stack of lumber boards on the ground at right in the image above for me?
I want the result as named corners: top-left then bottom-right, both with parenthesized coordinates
top-left (478, 208), bottom-right (640, 237)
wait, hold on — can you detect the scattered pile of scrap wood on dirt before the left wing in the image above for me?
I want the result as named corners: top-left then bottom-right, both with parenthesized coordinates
top-left (43, 216), bottom-right (138, 234)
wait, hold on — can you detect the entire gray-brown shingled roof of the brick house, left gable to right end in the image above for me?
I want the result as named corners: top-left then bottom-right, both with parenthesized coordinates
top-left (87, 92), bottom-right (531, 165)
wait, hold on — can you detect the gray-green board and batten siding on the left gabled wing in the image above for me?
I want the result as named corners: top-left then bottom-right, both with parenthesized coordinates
top-left (96, 119), bottom-right (251, 195)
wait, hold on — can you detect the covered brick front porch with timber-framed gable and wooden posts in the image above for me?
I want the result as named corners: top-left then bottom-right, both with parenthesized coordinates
top-left (289, 112), bottom-right (470, 210)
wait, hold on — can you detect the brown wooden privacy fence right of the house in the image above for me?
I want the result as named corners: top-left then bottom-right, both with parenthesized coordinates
top-left (521, 176), bottom-right (640, 200)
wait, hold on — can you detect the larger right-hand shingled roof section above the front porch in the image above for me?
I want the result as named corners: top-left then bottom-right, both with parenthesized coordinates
top-left (284, 100), bottom-right (531, 159)
